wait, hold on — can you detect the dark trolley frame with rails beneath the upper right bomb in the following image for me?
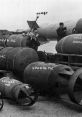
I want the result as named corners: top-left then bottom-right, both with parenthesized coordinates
top-left (47, 53), bottom-right (82, 70)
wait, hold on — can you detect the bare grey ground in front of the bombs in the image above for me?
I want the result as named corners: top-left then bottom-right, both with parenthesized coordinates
top-left (0, 97), bottom-right (82, 117)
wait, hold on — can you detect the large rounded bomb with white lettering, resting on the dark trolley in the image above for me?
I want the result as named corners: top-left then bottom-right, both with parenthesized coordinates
top-left (56, 34), bottom-right (82, 55)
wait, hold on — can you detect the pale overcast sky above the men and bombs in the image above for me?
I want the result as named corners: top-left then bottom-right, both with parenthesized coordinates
top-left (0, 0), bottom-right (82, 30)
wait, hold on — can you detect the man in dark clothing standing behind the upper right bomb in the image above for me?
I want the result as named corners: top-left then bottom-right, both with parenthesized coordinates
top-left (56, 22), bottom-right (67, 41)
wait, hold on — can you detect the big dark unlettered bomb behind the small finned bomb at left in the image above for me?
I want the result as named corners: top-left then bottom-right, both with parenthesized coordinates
top-left (0, 47), bottom-right (38, 74)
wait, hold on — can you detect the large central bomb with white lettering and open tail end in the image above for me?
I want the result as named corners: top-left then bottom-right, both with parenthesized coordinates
top-left (24, 62), bottom-right (73, 94)
